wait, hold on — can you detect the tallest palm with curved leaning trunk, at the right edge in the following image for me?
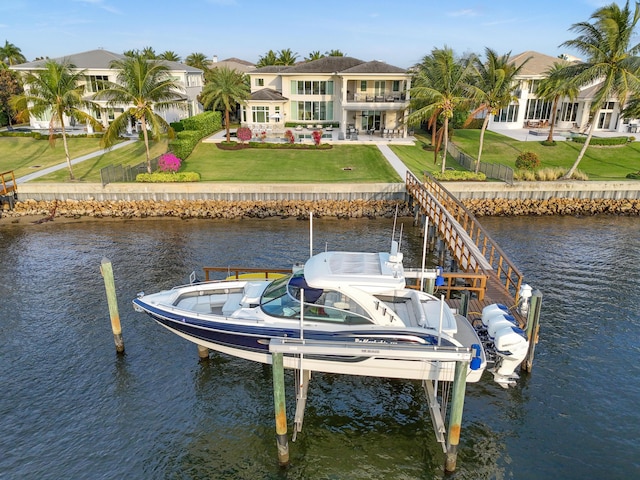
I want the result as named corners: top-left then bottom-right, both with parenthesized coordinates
top-left (561, 0), bottom-right (640, 179)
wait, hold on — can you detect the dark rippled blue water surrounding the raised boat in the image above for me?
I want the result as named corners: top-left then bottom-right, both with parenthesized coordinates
top-left (0, 217), bottom-right (640, 480)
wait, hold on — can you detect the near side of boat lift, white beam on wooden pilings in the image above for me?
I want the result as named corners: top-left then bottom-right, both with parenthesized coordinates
top-left (269, 335), bottom-right (476, 472)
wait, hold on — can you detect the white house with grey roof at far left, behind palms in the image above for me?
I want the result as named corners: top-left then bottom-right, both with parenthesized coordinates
top-left (11, 50), bottom-right (204, 130)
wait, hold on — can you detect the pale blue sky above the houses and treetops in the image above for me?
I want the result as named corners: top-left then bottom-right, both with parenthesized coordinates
top-left (0, 0), bottom-right (620, 68)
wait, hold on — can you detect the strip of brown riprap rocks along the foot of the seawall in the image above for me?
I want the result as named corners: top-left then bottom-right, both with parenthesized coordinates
top-left (0, 198), bottom-right (640, 223)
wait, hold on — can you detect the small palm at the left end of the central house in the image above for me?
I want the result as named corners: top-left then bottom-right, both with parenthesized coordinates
top-left (200, 66), bottom-right (251, 142)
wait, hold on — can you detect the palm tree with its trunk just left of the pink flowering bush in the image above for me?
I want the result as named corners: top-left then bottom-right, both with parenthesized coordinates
top-left (95, 54), bottom-right (185, 173)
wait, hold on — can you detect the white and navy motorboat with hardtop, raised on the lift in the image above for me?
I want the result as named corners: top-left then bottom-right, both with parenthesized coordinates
top-left (133, 235), bottom-right (510, 382)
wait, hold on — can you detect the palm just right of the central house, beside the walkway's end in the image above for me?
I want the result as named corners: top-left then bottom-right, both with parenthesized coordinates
top-left (407, 46), bottom-right (474, 173)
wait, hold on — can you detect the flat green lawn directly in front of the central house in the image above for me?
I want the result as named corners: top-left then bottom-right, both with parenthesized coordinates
top-left (183, 143), bottom-right (404, 183)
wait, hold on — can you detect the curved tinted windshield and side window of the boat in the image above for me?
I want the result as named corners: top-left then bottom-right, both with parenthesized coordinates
top-left (260, 273), bottom-right (373, 325)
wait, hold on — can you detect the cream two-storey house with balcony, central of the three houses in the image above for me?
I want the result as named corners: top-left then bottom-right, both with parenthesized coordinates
top-left (242, 57), bottom-right (411, 137)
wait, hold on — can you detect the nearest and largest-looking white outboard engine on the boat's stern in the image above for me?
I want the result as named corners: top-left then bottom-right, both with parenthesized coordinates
top-left (492, 322), bottom-right (529, 388)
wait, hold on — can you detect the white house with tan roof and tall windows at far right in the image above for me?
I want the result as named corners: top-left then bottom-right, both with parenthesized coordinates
top-left (488, 51), bottom-right (633, 132)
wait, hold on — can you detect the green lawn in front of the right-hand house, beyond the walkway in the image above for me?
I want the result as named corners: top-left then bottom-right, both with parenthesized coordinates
top-left (453, 130), bottom-right (640, 180)
